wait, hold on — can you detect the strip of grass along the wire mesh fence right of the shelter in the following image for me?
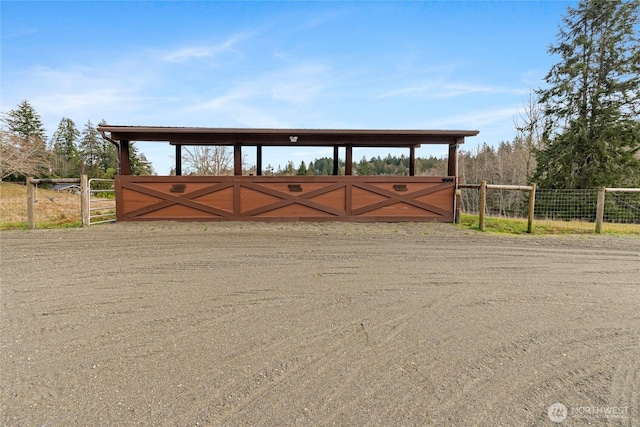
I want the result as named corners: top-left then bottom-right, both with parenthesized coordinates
top-left (458, 214), bottom-right (640, 236)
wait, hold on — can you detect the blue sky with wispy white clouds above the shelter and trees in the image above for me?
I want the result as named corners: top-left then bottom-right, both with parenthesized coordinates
top-left (0, 0), bottom-right (576, 175)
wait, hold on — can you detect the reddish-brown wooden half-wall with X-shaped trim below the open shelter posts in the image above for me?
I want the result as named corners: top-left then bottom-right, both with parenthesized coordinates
top-left (116, 175), bottom-right (455, 222)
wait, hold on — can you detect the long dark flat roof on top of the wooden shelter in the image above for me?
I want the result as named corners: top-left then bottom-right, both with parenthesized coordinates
top-left (98, 125), bottom-right (479, 147)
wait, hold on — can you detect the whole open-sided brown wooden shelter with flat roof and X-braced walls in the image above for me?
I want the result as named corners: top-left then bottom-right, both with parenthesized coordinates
top-left (98, 126), bottom-right (478, 222)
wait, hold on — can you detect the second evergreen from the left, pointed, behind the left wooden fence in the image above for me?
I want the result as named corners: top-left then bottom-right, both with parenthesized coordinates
top-left (51, 117), bottom-right (80, 177)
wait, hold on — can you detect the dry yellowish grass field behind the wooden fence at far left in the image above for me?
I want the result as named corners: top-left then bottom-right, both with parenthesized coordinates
top-left (0, 182), bottom-right (82, 230)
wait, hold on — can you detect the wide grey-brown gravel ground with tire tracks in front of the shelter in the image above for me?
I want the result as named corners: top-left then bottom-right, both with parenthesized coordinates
top-left (0, 222), bottom-right (640, 426)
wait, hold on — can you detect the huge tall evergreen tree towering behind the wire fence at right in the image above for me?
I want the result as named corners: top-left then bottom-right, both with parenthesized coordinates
top-left (533, 0), bottom-right (640, 188)
